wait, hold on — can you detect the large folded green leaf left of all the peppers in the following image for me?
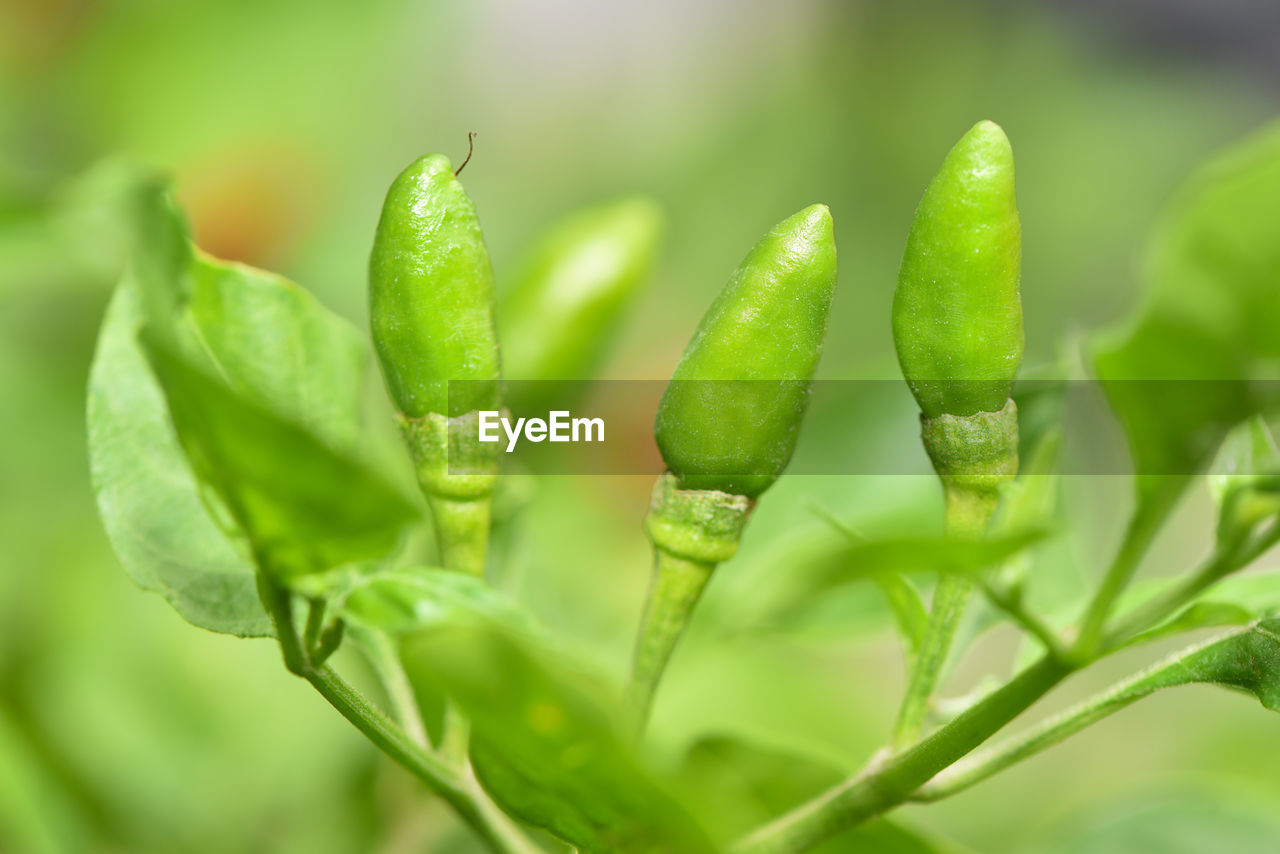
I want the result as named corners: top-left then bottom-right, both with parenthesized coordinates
top-left (90, 184), bottom-right (417, 622)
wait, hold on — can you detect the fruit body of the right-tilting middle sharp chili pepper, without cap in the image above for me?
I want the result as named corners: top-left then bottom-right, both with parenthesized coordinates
top-left (655, 205), bottom-right (836, 498)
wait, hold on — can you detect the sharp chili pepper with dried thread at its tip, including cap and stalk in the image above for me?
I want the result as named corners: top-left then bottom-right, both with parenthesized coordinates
top-left (369, 154), bottom-right (499, 574)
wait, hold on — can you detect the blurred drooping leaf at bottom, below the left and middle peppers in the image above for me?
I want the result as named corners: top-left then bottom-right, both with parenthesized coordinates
top-left (402, 622), bottom-right (714, 854)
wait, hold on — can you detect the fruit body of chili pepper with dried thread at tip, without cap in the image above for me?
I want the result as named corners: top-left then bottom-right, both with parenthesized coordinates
top-left (369, 154), bottom-right (499, 417)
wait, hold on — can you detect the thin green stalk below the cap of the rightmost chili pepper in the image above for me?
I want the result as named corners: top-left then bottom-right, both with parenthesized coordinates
top-left (891, 481), bottom-right (997, 748)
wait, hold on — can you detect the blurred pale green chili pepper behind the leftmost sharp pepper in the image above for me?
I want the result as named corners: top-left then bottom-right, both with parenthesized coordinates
top-left (498, 196), bottom-right (663, 410)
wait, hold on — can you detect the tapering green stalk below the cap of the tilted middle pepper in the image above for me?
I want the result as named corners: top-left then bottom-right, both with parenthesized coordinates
top-left (627, 547), bottom-right (716, 732)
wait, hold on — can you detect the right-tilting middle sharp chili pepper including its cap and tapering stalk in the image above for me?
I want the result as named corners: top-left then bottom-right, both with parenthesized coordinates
top-left (630, 205), bottom-right (836, 730)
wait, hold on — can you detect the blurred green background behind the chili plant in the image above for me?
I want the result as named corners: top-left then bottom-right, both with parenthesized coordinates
top-left (0, 0), bottom-right (1280, 854)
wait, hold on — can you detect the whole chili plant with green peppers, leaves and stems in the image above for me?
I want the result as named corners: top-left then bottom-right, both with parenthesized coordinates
top-left (88, 122), bottom-right (1280, 854)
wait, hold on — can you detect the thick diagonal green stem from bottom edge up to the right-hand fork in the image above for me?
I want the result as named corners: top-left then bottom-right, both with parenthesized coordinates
top-left (732, 656), bottom-right (1074, 854)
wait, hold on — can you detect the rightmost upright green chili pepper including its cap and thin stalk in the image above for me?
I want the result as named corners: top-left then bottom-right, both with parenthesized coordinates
top-left (893, 122), bottom-right (1023, 746)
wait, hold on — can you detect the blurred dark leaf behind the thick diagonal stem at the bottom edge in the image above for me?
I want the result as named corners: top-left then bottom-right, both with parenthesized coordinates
top-left (680, 736), bottom-right (959, 854)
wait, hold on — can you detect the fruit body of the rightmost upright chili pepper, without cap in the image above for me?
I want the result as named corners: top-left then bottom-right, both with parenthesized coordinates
top-left (893, 122), bottom-right (1023, 419)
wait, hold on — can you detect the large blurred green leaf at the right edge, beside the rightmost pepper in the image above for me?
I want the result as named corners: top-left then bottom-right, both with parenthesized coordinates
top-left (1094, 124), bottom-right (1280, 512)
